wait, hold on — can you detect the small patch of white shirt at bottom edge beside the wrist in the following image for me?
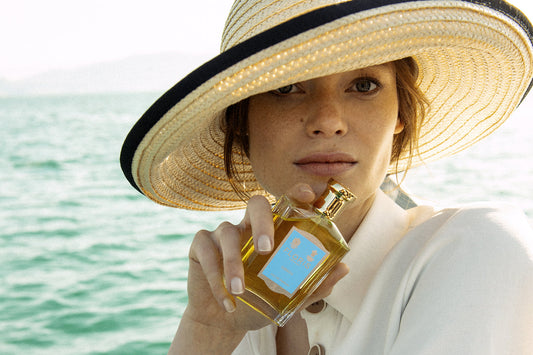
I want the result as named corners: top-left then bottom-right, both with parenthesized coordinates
top-left (232, 325), bottom-right (276, 355)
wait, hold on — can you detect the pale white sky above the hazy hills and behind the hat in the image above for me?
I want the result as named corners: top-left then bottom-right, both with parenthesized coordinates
top-left (0, 0), bottom-right (533, 80)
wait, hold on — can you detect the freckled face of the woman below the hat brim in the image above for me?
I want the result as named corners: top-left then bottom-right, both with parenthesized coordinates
top-left (248, 63), bottom-right (403, 211)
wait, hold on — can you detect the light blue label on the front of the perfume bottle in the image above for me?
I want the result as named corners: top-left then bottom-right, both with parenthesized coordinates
top-left (259, 227), bottom-right (329, 297)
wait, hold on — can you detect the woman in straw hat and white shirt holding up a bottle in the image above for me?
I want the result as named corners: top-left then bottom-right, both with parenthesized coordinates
top-left (121, 0), bottom-right (533, 354)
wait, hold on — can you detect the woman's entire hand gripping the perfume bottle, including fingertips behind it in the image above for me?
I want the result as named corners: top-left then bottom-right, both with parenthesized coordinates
top-left (167, 184), bottom-right (347, 353)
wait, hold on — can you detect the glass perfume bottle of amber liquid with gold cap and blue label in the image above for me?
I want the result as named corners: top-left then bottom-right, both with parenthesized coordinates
top-left (238, 180), bottom-right (355, 326)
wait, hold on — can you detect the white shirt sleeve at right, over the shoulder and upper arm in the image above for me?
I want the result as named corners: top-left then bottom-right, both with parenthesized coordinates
top-left (387, 207), bottom-right (533, 355)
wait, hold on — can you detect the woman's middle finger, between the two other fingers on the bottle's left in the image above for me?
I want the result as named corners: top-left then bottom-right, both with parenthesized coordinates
top-left (214, 222), bottom-right (244, 295)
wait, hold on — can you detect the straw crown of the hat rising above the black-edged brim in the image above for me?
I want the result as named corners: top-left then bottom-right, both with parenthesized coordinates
top-left (220, 0), bottom-right (348, 52)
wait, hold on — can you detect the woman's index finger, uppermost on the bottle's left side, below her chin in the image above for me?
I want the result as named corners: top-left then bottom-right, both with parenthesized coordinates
top-left (240, 195), bottom-right (274, 254)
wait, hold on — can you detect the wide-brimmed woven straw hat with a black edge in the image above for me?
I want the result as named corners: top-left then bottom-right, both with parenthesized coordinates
top-left (121, 0), bottom-right (533, 210)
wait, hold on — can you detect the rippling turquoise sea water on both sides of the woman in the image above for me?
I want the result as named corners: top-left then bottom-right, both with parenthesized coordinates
top-left (0, 94), bottom-right (533, 354)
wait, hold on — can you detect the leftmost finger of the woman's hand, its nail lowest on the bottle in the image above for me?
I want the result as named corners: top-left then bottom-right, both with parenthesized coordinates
top-left (189, 231), bottom-right (235, 312)
